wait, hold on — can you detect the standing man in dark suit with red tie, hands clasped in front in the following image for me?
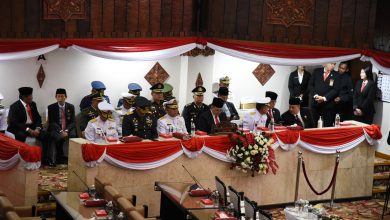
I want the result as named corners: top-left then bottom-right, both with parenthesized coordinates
top-left (309, 63), bottom-right (338, 127)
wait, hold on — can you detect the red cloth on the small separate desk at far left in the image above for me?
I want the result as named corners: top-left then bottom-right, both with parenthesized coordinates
top-left (0, 133), bottom-right (41, 162)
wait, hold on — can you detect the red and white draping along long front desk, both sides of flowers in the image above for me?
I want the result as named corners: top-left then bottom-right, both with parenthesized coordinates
top-left (82, 125), bottom-right (382, 170)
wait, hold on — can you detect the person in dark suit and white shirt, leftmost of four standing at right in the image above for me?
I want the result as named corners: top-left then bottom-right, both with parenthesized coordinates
top-left (288, 66), bottom-right (311, 107)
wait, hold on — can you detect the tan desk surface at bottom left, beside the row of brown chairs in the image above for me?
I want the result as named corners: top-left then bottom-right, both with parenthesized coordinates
top-left (52, 192), bottom-right (102, 220)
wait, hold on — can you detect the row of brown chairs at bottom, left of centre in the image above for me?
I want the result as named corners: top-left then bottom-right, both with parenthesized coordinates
top-left (95, 177), bottom-right (156, 220)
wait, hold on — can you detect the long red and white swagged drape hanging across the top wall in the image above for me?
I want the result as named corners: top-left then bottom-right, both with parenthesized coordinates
top-left (0, 37), bottom-right (390, 74)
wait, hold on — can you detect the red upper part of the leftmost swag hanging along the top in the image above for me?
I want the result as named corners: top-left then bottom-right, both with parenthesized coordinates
top-left (0, 40), bottom-right (60, 53)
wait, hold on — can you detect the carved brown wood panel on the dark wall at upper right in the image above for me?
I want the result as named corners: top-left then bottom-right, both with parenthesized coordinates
top-left (265, 0), bottom-right (314, 27)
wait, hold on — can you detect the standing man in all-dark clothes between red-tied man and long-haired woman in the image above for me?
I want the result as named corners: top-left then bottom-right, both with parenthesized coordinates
top-left (334, 62), bottom-right (353, 121)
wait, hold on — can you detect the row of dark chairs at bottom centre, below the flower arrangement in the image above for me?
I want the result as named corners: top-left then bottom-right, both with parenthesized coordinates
top-left (215, 176), bottom-right (272, 220)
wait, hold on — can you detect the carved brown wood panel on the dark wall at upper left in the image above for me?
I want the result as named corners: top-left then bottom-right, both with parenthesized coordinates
top-left (43, 0), bottom-right (87, 22)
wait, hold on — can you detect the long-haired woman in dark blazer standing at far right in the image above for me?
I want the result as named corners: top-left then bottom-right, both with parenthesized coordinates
top-left (353, 67), bottom-right (376, 124)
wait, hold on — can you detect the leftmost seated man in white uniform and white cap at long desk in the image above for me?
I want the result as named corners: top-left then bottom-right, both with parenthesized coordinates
top-left (85, 101), bottom-right (118, 143)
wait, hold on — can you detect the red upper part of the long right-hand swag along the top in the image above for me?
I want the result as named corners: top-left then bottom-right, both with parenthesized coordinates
top-left (206, 38), bottom-right (362, 58)
